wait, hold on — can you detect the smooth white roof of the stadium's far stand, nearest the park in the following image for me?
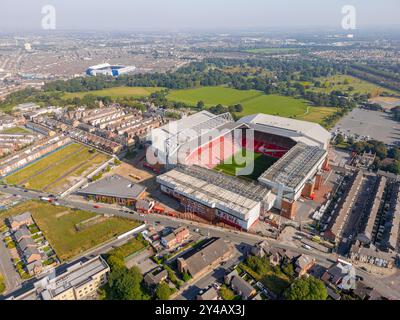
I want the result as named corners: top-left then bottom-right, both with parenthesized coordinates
top-left (238, 113), bottom-right (331, 149)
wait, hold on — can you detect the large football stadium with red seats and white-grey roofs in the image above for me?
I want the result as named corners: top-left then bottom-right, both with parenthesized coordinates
top-left (149, 111), bottom-right (330, 230)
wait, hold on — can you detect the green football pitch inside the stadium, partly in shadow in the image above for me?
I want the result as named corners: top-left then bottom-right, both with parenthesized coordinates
top-left (214, 150), bottom-right (278, 180)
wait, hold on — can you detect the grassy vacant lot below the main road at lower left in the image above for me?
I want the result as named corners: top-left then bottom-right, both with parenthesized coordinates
top-left (0, 200), bottom-right (139, 260)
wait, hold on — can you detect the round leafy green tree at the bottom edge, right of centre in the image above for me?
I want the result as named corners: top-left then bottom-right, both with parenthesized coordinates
top-left (284, 276), bottom-right (328, 300)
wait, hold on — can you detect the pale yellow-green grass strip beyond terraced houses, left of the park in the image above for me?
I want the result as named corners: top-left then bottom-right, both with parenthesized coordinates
top-left (63, 87), bottom-right (162, 99)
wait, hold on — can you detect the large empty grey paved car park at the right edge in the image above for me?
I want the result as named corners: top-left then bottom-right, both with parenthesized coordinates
top-left (333, 108), bottom-right (400, 145)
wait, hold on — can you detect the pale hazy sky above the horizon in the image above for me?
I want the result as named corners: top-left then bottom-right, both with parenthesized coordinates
top-left (0, 0), bottom-right (400, 31)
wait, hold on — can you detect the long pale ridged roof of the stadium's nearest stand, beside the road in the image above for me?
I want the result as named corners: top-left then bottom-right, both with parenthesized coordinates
top-left (157, 166), bottom-right (270, 220)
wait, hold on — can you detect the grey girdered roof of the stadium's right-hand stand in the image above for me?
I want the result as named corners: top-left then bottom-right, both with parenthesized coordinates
top-left (259, 143), bottom-right (327, 189)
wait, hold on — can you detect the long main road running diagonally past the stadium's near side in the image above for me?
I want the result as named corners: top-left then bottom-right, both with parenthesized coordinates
top-left (0, 187), bottom-right (400, 300)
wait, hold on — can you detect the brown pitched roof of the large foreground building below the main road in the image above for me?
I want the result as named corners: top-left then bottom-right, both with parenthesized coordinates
top-left (179, 238), bottom-right (230, 276)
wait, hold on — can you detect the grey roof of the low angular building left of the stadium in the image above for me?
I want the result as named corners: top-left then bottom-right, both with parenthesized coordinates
top-left (78, 174), bottom-right (146, 199)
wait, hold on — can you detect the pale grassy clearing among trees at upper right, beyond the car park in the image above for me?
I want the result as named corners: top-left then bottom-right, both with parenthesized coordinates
top-left (309, 74), bottom-right (398, 97)
